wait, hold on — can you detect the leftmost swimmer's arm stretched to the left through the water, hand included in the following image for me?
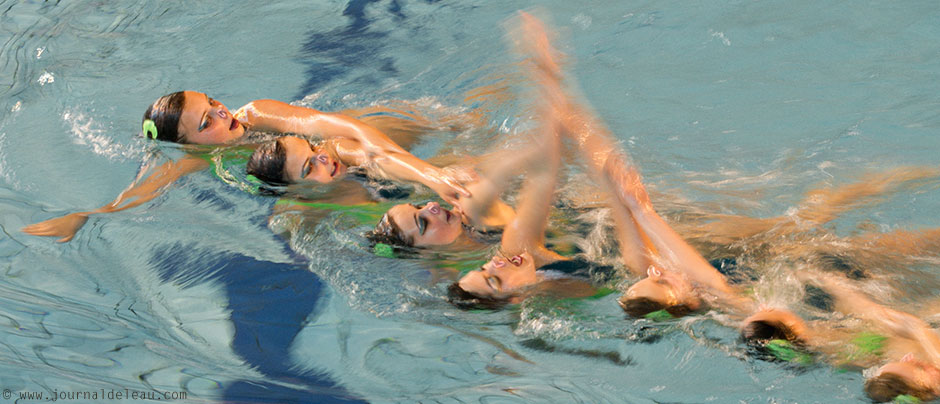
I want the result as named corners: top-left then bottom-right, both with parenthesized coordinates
top-left (22, 157), bottom-right (209, 243)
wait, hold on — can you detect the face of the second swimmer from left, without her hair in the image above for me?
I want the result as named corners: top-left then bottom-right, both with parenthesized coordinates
top-left (277, 136), bottom-right (346, 184)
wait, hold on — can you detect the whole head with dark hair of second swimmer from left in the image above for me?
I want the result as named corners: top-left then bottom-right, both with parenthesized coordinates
top-left (247, 136), bottom-right (346, 185)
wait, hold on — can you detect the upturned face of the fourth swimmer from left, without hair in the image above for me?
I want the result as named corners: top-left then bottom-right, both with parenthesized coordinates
top-left (457, 253), bottom-right (538, 299)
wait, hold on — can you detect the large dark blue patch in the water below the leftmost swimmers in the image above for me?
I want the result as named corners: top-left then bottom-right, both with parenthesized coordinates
top-left (151, 243), bottom-right (360, 403)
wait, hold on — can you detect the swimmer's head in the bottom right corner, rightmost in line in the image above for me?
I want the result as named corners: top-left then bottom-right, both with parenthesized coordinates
top-left (865, 354), bottom-right (940, 402)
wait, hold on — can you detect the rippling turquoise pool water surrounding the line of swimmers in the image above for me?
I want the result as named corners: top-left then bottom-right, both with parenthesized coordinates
top-left (0, 0), bottom-right (940, 403)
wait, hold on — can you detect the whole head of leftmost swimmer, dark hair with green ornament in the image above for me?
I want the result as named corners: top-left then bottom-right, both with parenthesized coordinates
top-left (143, 91), bottom-right (245, 144)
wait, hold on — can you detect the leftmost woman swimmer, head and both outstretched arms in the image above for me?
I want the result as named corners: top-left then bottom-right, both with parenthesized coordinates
top-left (23, 91), bottom-right (470, 242)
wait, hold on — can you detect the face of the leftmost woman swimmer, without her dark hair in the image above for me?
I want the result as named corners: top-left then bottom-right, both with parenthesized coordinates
top-left (178, 91), bottom-right (245, 144)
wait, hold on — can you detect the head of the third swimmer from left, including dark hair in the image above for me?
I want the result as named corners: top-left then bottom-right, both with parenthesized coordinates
top-left (372, 202), bottom-right (464, 247)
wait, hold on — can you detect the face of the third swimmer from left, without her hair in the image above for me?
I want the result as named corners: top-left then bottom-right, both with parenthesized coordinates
top-left (388, 202), bottom-right (463, 247)
